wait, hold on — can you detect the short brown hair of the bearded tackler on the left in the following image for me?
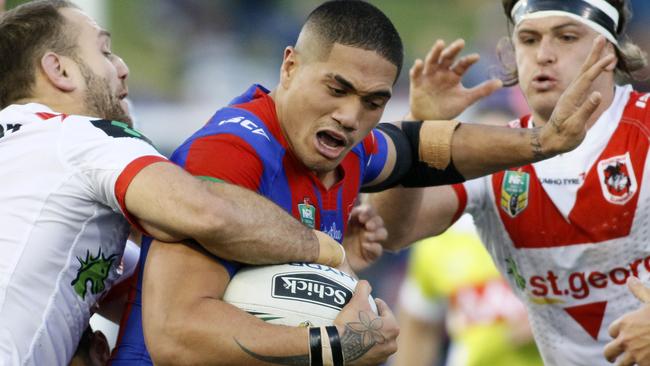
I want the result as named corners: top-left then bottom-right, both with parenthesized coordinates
top-left (0, 0), bottom-right (78, 108)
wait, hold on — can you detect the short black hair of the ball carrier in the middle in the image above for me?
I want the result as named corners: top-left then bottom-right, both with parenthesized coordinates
top-left (304, 0), bottom-right (404, 81)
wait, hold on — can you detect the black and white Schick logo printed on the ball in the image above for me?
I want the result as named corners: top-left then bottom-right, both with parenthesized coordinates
top-left (272, 272), bottom-right (352, 310)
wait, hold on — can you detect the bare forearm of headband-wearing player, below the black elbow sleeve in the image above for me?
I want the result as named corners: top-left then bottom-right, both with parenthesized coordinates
top-left (369, 186), bottom-right (458, 250)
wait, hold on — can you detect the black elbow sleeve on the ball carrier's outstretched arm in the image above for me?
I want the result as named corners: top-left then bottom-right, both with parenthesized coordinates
top-left (362, 122), bottom-right (465, 193)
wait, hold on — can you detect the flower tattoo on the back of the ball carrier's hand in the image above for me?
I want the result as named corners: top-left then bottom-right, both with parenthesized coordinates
top-left (341, 311), bottom-right (386, 362)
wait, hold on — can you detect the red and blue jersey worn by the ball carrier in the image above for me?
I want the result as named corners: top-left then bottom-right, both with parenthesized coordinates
top-left (113, 85), bottom-right (388, 365)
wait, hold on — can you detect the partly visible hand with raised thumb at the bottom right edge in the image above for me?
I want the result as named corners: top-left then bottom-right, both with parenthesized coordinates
top-left (604, 277), bottom-right (650, 366)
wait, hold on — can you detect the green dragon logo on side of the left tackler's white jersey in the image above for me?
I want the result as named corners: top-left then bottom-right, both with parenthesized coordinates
top-left (70, 248), bottom-right (117, 300)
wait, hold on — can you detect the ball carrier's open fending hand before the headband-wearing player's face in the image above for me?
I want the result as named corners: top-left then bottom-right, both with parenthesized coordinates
top-left (540, 36), bottom-right (616, 157)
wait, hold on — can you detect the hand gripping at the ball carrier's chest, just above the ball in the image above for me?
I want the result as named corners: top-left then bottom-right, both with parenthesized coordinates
top-left (343, 204), bottom-right (388, 272)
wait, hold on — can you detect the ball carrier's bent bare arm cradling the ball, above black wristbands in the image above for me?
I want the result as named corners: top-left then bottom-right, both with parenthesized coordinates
top-left (142, 241), bottom-right (309, 365)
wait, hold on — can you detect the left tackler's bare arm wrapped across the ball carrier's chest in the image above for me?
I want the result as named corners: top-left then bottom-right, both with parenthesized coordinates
top-left (125, 163), bottom-right (339, 264)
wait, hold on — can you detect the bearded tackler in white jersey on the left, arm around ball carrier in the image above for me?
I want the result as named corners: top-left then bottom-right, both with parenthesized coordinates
top-left (0, 1), bottom-right (350, 365)
